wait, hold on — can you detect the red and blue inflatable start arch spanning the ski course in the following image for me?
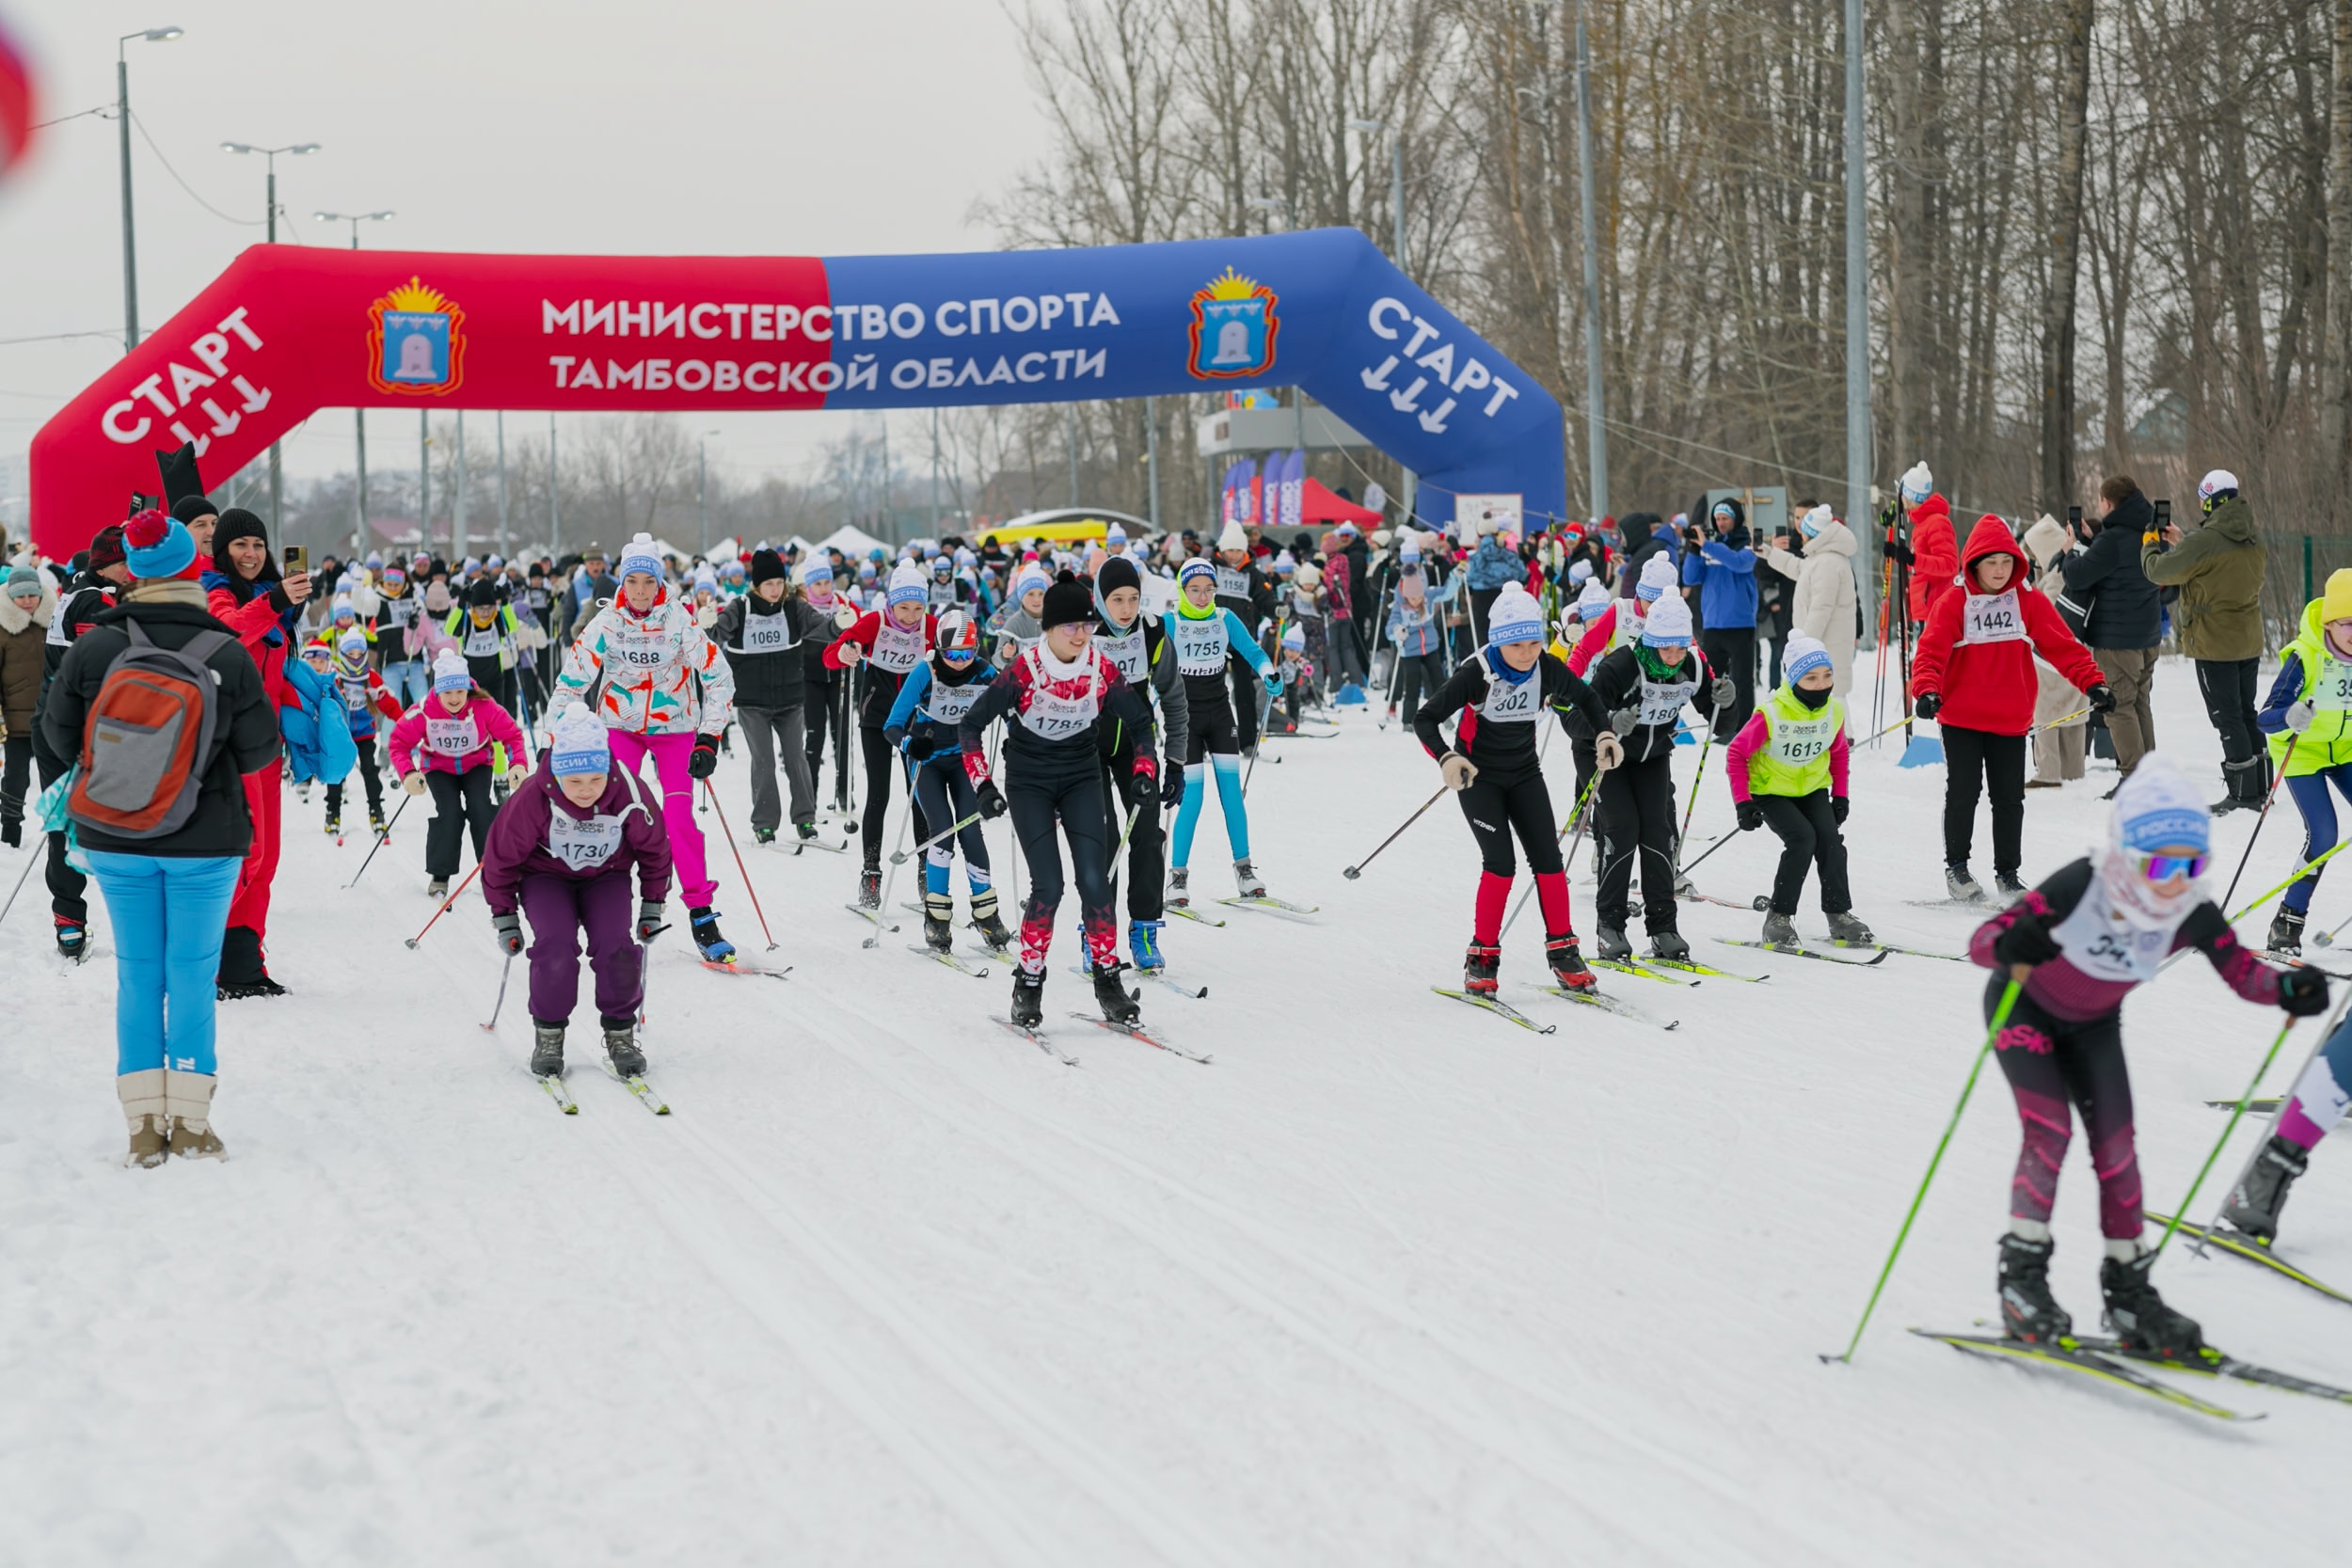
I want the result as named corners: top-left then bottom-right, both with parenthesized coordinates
top-left (33, 228), bottom-right (1566, 557)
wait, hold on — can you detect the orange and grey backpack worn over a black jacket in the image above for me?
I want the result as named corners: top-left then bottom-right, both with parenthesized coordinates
top-left (66, 621), bottom-right (235, 839)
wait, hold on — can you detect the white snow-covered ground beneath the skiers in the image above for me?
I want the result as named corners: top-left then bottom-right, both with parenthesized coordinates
top-left (0, 660), bottom-right (2352, 1568)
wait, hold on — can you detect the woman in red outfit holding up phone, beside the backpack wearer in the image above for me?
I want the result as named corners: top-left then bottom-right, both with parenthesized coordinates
top-left (202, 505), bottom-right (310, 1002)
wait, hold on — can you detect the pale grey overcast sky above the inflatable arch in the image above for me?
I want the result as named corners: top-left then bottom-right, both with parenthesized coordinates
top-left (0, 0), bottom-right (1047, 517)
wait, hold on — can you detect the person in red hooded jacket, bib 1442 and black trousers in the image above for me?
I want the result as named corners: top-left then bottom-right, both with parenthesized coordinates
top-left (1913, 513), bottom-right (2115, 903)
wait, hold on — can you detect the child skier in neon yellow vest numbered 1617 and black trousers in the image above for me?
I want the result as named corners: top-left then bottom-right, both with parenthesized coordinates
top-left (1724, 632), bottom-right (1877, 947)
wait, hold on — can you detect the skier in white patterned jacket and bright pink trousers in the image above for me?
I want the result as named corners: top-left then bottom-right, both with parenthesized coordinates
top-left (555, 533), bottom-right (734, 964)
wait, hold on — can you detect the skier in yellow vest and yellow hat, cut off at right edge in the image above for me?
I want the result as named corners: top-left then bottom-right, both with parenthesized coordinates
top-left (2256, 569), bottom-right (2352, 955)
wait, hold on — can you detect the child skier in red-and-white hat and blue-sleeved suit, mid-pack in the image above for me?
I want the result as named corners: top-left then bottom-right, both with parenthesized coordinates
top-left (882, 609), bottom-right (1014, 952)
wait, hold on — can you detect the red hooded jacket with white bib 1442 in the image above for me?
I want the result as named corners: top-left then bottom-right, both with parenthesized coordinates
top-left (1913, 513), bottom-right (2106, 736)
